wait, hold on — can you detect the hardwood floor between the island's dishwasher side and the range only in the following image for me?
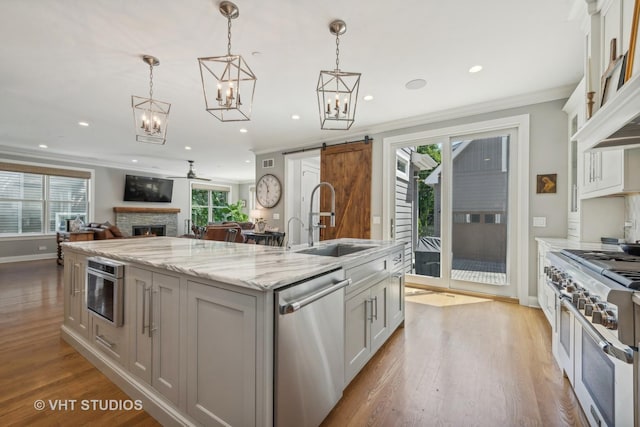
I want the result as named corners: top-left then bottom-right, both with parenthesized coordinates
top-left (323, 290), bottom-right (588, 427)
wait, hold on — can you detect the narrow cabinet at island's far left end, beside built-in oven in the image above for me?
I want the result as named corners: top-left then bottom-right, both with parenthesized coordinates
top-left (64, 252), bottom-right (89, 338)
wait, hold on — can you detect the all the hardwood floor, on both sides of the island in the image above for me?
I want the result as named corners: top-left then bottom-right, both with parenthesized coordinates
top-left (0, 260), bottom-right (587, 426)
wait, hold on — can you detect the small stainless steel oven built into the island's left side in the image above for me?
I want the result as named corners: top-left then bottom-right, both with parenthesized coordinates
top-left (86, 257), bottom-right (124, 326)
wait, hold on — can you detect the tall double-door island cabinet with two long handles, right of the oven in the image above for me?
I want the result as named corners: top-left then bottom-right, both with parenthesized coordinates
top-left (125, 267), bottom-right (180, 404)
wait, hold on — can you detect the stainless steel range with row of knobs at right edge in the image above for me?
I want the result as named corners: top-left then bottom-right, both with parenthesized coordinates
top-left (545, 249), bottom-right (640, 427)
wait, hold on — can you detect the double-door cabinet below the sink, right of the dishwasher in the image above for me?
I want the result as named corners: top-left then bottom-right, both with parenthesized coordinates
top-left (344, 277), bottom-right (390, 384)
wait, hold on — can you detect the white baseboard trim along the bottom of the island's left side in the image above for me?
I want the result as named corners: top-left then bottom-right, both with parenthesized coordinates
top-left (60, 325), bottom-right (199, 427)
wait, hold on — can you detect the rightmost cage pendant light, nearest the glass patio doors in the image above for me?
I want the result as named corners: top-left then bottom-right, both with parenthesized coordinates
top-left (317, 20), bottom-right (361, 130)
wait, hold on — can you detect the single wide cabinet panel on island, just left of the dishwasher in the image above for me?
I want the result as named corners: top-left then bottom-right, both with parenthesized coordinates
top-left (186, 281), bottom-right (257, 426)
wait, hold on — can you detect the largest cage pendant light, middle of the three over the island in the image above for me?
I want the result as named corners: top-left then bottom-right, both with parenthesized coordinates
top-left (198, 1), bottom-right (257, 122)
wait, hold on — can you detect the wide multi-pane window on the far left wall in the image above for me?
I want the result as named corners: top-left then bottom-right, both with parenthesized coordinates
top-left (0, 163), bottom-right (91, 236)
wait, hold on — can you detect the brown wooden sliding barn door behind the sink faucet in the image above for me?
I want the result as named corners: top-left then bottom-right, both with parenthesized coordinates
top-left (320, 140), bottom-right (372, 240)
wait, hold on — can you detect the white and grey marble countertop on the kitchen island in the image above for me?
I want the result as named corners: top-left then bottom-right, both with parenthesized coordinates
top-left (63, 237), bottom-right (402, 290)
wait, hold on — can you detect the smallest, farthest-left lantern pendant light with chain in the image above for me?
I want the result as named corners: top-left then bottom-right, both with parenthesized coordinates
top-left (131, 55), bottom-right (171, 145)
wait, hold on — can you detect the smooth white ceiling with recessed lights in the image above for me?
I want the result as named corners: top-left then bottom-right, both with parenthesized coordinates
top-left (0, 0), bottom-right (584, 181)
